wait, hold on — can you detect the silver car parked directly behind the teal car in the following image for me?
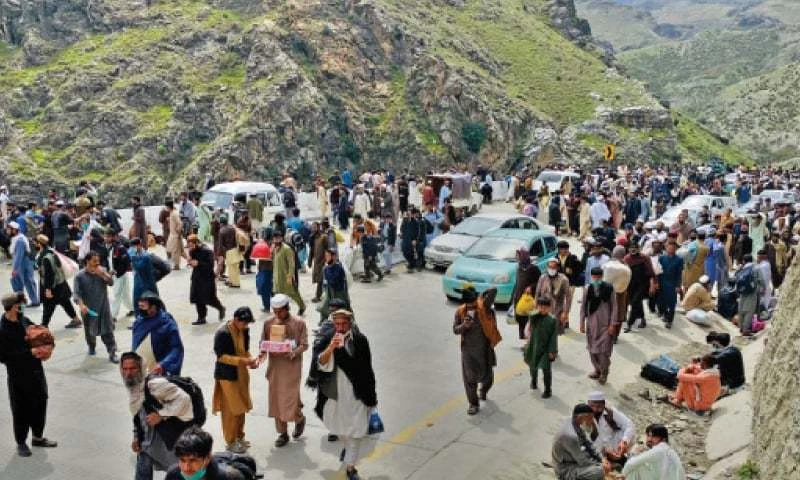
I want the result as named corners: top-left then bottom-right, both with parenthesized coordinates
top-left (425, 213), bottom-right (542, 268)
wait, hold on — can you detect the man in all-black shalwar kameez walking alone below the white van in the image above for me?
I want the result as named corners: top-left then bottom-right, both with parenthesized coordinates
top-left (186, 234), bottom-right (225, 325)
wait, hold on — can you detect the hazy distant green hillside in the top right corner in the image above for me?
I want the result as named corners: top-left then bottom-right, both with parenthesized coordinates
top-left (578, 0), bottom-right (800, 161)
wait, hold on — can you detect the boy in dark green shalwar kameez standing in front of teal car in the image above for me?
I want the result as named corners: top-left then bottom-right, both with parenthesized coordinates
top-left (524, 297), bottom-right (558, 398)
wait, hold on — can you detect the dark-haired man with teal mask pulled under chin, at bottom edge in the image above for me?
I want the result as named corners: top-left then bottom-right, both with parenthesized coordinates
top-left (165, 427), bottom-right (247, 480)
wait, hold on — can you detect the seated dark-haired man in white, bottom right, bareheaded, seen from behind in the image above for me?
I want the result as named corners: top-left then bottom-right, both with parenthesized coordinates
top-left (622, 424), bottom-right (686, 480)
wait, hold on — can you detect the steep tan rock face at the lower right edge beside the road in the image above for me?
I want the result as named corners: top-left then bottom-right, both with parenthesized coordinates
top-left (751, 266), bottom-right (800, 480)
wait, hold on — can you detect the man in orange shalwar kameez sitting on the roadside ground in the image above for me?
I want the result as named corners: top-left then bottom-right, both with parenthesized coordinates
top-left (661, 355), bottom-right (722, 414)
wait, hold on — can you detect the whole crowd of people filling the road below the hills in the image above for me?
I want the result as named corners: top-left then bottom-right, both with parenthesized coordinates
top-left (0, 162), bottom-right (788, 480)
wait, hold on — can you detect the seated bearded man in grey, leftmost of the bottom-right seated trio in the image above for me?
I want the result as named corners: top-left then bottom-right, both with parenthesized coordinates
top-left (552, 403), bottom-right (611, 480)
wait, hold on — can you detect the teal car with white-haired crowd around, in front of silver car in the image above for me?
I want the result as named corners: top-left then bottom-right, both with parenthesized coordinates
top-left (442, 229), bottom-right (558, 304)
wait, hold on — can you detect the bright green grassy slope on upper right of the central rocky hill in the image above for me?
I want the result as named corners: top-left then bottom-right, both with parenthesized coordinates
top-left (380, 0), bottom-right (653, 125)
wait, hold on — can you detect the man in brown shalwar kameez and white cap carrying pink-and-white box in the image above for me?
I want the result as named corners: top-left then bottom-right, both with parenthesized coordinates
top-left (261, 293), bottom-right (308, 447)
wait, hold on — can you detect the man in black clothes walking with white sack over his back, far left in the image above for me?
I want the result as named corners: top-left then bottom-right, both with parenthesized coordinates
top-left (35, 235), bottom-right (81, 328)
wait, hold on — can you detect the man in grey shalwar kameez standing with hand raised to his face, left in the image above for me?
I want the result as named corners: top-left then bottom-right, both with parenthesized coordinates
top-left (72, 252), bottom-right (119, 363)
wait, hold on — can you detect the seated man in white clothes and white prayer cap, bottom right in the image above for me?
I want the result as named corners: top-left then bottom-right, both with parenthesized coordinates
top-left (586, 391), bottom-right (636, 464)
